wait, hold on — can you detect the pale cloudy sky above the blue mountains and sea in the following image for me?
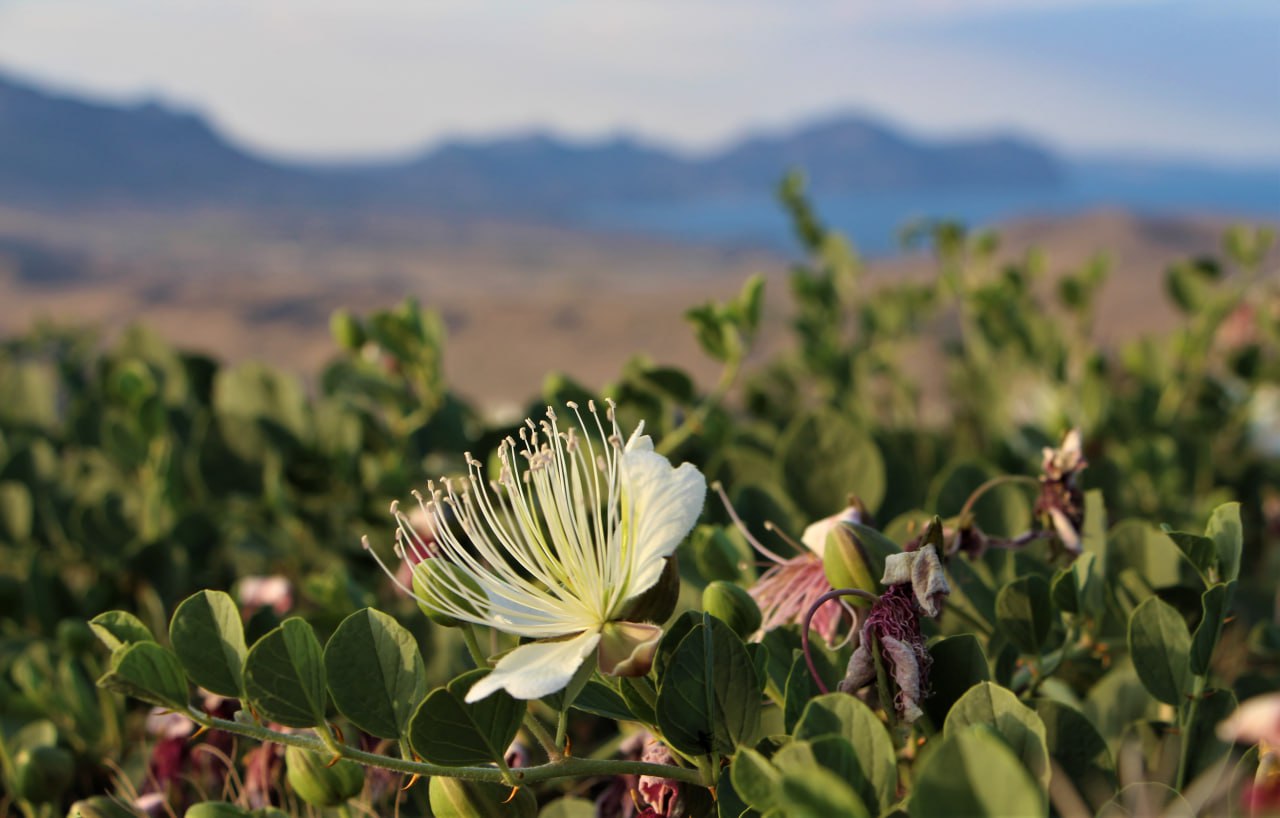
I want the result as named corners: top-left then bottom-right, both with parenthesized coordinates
top-left (0, 0), bottom-right (1280, 164)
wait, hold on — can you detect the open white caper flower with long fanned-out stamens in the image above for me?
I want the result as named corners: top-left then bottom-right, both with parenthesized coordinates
top-left (375, 402), bottom-right (707, 702)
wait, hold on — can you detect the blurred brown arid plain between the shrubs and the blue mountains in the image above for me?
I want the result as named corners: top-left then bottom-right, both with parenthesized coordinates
top-left (0, 209), bottom-right (1269, 407)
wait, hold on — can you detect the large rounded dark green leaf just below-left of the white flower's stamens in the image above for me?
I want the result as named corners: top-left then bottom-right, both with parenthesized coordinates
top-left (324, 608), bottom-right (430, 750)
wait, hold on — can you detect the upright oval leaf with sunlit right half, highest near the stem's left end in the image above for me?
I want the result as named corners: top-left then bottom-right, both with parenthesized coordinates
top-left (169, 590), bottom-right (248, 699)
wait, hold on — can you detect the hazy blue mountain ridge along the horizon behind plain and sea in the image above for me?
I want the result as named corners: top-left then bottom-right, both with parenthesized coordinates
top-left (0, 76), bottom-right (1061, 216)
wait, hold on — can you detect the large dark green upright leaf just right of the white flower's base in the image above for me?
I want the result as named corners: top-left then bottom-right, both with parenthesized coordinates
top-left (655, 614), bottom-right (762, 755)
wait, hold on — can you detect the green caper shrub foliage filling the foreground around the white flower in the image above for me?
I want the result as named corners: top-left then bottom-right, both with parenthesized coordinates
top-left (0, 178), bottom-right (1280, 818)
